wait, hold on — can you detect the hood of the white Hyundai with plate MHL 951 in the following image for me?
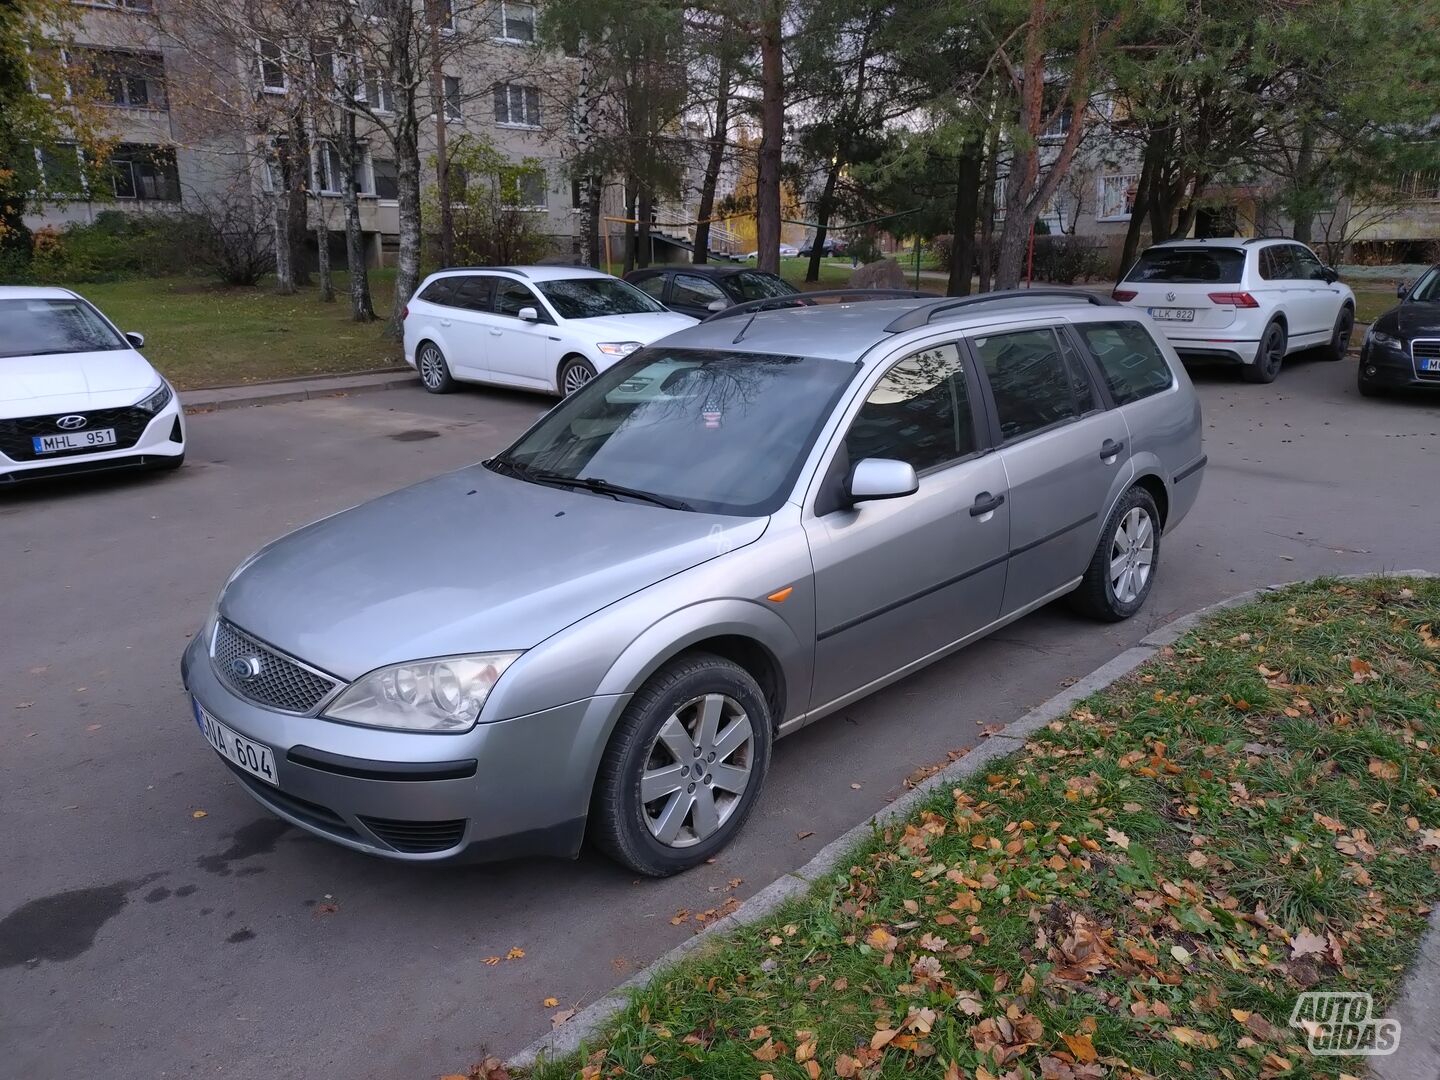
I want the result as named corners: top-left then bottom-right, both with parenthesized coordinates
top-left (0, 348), bottom-right (160, 416)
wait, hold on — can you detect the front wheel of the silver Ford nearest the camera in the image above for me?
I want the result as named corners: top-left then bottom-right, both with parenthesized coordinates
top-left (590, 652), bottom-right (772, 877)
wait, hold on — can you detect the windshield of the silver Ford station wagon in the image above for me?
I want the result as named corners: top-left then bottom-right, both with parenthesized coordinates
top-left (500, 347), bottom-right (858, 516)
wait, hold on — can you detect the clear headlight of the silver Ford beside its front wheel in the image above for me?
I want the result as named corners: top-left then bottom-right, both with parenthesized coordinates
top-left (324, 652), bottom-right (520, 732)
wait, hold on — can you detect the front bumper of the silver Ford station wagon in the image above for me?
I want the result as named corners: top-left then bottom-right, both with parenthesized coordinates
top-left (180, 636), bottom-right (628, 863)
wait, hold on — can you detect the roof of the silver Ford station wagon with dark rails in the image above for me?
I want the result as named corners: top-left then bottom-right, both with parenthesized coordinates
top-left (665, 289), bottom-right (1140, 361)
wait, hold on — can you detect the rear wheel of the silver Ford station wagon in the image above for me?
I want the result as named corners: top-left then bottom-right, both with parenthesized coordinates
top-left (1070, 485), bottom-right (1161, 622)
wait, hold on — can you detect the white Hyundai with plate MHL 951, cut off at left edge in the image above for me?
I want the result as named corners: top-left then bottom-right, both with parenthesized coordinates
top-left (0, 285), bottom-right (184, 484)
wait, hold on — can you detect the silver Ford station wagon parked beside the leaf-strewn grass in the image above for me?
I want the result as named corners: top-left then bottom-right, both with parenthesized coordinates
top-left (183, 289), bottom-right (1205, 876)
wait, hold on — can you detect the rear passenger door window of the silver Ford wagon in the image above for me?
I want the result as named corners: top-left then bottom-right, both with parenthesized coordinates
top-left (971, 330), bottom-right (1079, 441)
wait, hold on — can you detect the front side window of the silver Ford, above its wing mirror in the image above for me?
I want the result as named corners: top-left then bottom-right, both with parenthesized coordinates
top-left (845, 344), bottom-right (976, 472)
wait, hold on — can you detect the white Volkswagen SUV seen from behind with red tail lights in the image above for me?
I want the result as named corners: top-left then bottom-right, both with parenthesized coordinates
top-left (1112, 238), bottom-right (1355, 383)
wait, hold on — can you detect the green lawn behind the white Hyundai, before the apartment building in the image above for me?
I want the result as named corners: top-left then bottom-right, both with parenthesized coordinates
top-left (73, 271), bottom-right (400, 390)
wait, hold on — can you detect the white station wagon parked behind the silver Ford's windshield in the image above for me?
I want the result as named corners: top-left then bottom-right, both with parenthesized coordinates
top-left (403, 266), bottom-right (697, 396)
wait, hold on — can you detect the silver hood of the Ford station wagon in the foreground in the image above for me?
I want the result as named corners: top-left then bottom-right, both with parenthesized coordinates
top-left (220, 465), bottom-right (769, 680)
